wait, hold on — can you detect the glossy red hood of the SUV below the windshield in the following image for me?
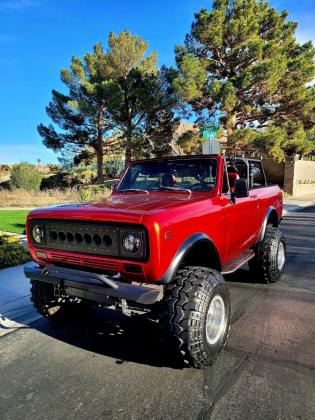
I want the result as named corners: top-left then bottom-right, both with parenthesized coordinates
top-left (30, 192), bottom-right (212, 223)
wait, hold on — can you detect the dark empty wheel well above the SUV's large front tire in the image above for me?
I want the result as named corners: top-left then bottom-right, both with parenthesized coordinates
top-left (180, 240), bottom-right (222, 271)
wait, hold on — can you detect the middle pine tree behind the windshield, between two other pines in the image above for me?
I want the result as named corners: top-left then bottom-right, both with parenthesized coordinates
top-left (103, 31), bottom-right (179, 165)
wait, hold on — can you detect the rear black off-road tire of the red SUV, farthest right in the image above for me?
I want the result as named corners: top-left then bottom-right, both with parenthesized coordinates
top-left (248, 225), bottom-right (286, 283)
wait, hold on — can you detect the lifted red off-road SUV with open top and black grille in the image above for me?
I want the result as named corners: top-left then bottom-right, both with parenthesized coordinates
top-left (25, 155), bottom-right (286, 367)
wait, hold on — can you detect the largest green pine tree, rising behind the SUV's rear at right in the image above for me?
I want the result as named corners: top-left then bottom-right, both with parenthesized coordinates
top-left (174, 0), bottom-right (315, 159)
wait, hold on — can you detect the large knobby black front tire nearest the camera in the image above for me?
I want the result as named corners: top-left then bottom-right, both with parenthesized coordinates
top-left (160, 266), bottom-right (231, 368)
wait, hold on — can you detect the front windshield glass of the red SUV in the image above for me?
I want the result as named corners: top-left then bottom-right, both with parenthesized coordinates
top-left (118, 158), bottom-right (217, 192)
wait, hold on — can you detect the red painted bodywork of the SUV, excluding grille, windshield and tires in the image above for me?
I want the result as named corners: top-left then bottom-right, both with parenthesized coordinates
top-left (27, 156), bottom-right (282, 283)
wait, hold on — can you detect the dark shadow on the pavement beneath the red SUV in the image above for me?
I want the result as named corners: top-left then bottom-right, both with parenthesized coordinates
top-left (26, 270), bottom-right (255, 369)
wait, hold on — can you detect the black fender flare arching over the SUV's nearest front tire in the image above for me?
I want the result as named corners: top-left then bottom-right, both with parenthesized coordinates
top-left (157, 232), bottom-right (222, 285)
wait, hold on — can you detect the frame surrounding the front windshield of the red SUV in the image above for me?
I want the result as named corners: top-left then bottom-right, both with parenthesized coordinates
top-left (115, 155), bottom-right (219, 194)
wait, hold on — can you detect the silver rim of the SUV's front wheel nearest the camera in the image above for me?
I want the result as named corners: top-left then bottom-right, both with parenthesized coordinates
top-left (206, 295), bottom-right (227, 345)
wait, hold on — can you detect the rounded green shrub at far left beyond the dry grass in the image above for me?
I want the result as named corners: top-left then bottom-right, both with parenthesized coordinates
top-left (10, 162), bottom-right (43, 191)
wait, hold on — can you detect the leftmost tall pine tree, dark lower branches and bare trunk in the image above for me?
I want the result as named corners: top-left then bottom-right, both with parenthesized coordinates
top-left (38, 44), bottom-right (112, 183)
